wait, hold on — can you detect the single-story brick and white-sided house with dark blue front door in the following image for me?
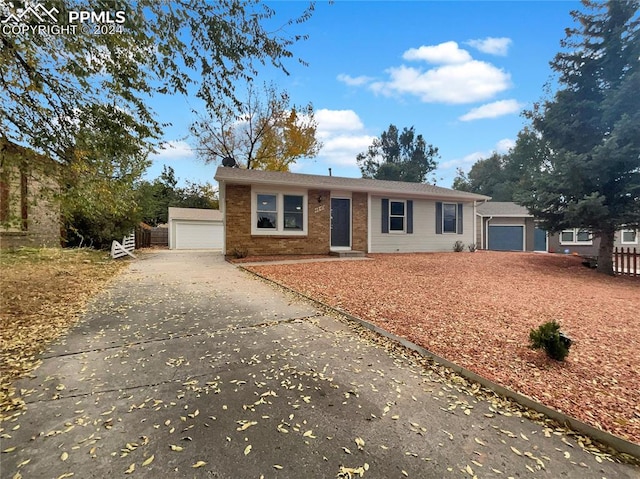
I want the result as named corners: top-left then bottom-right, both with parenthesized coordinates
top-left (215, 166), bottom-right (489, 255)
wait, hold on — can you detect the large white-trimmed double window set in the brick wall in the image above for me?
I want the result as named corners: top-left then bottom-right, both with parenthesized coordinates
top-left (251, 191), bottom-right (307, 235)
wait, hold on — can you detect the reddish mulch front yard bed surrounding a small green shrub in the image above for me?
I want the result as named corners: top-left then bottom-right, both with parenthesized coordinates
top-left (248, 251), bottom-right (640, 443)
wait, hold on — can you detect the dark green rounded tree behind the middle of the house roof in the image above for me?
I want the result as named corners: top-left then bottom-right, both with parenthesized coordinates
top-left (356, 124), bottom-right (439, 183)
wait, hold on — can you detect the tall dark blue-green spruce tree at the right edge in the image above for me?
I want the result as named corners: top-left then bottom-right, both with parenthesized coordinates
top-left (518, 0), bottom-right (640, 274)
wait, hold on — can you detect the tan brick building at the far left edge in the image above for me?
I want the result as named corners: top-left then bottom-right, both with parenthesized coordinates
top-left (0, 139), bottom-right (61, 248)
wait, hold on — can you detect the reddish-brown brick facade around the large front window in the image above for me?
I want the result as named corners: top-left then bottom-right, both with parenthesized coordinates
top-left (224, 184), bottom-right (332, 256)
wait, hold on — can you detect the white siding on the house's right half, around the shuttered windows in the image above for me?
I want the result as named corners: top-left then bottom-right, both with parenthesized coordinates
top-left (369, 196), bottom-right (475, 253)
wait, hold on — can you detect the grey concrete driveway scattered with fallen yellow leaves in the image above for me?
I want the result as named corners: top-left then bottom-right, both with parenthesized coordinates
top-left (0, 251), bottom-right (640, 479)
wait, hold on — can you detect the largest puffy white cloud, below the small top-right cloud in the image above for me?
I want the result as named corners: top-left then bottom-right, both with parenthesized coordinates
top-left (371, 60), bottom-right (511, 104)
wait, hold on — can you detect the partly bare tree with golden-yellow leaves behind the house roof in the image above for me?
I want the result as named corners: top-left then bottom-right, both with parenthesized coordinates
top-left (191, 85), bottom-right (322, 171)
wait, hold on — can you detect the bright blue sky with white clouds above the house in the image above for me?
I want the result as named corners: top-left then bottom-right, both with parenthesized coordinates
top-left (146, 0), bottom-right (580, 187)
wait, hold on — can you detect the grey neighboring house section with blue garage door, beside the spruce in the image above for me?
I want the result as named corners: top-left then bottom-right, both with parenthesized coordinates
top-left (476, 201), bottom-right (548, 251)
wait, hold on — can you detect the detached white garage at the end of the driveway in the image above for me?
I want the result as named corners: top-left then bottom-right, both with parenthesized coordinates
top-left (169, 207), bottom-right (224, 249)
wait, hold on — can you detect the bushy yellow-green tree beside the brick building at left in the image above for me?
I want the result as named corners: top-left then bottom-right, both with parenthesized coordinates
top-left (59, 105), bottom-right (150, 248)
